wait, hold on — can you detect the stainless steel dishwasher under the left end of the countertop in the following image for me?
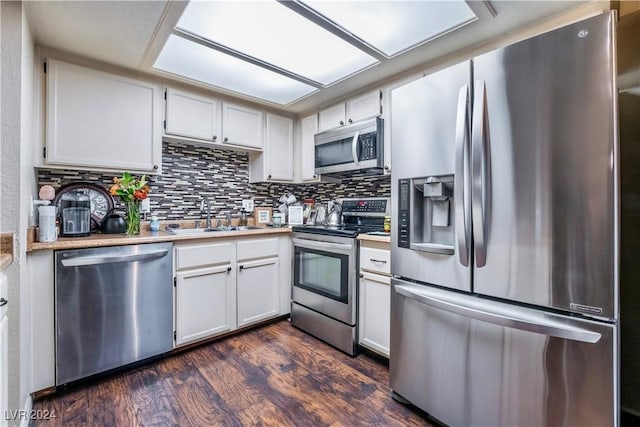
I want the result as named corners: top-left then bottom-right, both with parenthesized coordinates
top-left (55, 243), bottom-right (173, 385)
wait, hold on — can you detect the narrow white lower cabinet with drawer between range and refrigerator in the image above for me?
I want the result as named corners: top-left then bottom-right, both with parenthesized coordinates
top-left (358, 241), bottom-right (391, 357)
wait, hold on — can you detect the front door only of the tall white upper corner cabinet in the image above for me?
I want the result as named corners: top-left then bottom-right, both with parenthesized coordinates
top-left (265, 114), bottom-right (293, 181)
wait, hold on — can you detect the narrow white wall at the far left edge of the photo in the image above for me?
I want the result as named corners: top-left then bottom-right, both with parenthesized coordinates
top-left (0, 1), bottom-right (35, 422)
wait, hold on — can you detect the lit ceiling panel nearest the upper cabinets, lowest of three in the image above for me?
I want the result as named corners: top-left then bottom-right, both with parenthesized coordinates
top-left (153, 35), bottom-right (318, 105)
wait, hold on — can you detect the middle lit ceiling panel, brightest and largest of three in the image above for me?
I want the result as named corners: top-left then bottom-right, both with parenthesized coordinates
top-left (176, 1), bottom-right (378, 85)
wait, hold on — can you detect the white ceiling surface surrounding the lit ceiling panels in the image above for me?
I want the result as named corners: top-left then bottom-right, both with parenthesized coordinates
top-left (26, 0), bottom-right (596, 113)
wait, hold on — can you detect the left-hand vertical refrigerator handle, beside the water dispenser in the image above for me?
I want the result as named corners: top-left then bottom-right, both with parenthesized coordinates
top-left (453, 85), bottom-right (470, 267)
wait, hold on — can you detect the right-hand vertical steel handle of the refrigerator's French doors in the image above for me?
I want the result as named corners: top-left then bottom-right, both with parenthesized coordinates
top-left (471, 80), bottom-right (491, 267)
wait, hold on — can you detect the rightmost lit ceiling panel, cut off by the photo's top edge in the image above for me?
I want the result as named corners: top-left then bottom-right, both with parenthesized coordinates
top-left (304, 0), bottom-right (477, 57)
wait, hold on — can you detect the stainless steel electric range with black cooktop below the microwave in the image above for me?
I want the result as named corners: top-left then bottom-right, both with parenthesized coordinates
top-left (291, 198), bottom-right (390, 356)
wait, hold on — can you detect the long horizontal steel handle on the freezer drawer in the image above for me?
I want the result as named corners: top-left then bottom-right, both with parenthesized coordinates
top-left (394, 285), bottom-right (602, 344)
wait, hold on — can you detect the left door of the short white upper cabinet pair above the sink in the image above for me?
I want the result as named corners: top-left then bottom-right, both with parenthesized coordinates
top-left (165, 88), bottom-right (220, 142)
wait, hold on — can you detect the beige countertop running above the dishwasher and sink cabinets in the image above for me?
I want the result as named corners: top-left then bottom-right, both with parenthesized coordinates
top-left (27, 227), bottom-right (291, 252)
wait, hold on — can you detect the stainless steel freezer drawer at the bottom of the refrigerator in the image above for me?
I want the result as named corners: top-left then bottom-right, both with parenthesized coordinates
top-left (390, 279), bottom-right (618, 426)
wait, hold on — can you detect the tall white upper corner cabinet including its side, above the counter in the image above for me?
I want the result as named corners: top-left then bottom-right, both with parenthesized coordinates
top-left (249, 114), bottom-right (293, 182)
